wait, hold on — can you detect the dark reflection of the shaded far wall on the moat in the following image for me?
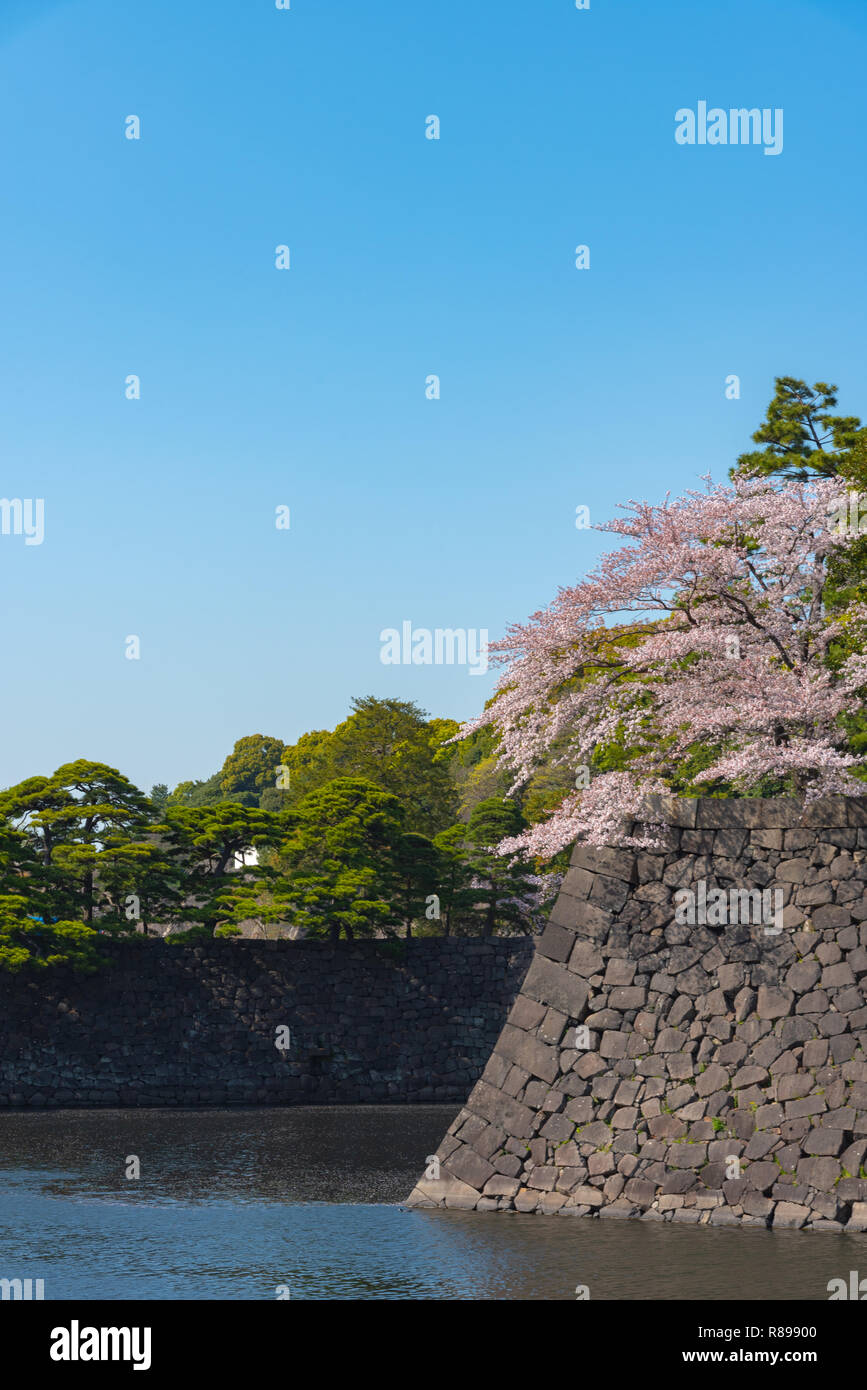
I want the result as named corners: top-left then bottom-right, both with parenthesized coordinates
top-left (0, 1105), bottom-right (444, 1207)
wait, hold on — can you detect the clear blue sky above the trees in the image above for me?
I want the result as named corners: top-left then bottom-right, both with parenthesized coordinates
top-left (0, 0), bottom-right (867, 790)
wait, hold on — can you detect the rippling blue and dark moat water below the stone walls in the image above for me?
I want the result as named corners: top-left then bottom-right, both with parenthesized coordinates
top-left (0, 1105), bottom-right (867, 1301)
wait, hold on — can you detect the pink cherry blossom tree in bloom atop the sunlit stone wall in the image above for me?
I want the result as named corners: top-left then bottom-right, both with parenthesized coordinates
top-left (460, 478), bottom-right (867, 858)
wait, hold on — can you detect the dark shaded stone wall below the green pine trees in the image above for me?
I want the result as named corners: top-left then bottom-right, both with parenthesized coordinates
top-left (0, 938), bottom-right (534, 1106)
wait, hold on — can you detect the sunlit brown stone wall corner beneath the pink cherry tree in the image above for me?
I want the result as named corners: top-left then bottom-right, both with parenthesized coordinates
top-left (410, 798), bottom-right (867, 1232)
